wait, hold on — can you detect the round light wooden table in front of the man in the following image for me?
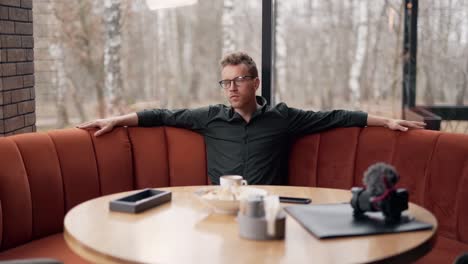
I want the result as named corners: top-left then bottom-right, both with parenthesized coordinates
top-left (64, 186), bottom-right (437, 263)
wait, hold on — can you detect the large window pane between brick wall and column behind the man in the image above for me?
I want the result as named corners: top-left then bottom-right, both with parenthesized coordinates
top-left (33, 0), bottom-right (262, 130)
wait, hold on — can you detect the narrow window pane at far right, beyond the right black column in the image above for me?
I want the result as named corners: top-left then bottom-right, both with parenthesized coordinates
top-left (416, 0), bottom-right (468, 106)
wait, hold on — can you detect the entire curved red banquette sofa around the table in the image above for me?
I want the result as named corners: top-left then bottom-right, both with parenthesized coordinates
top-left (0, 127), bottom-right (468, 263)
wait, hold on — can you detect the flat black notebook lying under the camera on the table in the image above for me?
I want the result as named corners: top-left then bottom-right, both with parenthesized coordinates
top-left (284, 203), bottom-right (432, 238)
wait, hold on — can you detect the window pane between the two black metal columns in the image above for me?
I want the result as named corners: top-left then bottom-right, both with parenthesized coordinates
top-left (275, 0), bottom-right (404, 117)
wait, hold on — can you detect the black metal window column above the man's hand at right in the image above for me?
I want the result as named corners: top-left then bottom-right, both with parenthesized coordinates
top-left (402, 0), bottom-right (418, 118)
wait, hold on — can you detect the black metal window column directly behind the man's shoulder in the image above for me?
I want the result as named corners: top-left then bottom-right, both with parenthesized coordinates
top-left (262, 0), bottom-right (275, 105)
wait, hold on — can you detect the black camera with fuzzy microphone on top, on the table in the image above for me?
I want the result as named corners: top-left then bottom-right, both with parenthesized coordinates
top-left (351, 163), bottom-right (409, 223)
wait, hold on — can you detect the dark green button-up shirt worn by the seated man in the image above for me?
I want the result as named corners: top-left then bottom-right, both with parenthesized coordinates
top-left (137, 96), bottom-right (367, 184)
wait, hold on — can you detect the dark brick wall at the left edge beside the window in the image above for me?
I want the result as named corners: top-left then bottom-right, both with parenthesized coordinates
top-left (0, 0), bottom-right (36, 136)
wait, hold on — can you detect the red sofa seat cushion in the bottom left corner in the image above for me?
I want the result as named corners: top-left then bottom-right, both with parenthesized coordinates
top-left (0, 233), bottom-right (89, 264)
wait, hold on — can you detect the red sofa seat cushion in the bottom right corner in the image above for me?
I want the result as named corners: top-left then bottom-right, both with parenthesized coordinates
top-left (417, 235), bottom-right (468, 264)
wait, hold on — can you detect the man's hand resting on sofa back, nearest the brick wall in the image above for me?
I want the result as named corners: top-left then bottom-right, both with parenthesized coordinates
top-left (76, 113), bottom-right (138, 137)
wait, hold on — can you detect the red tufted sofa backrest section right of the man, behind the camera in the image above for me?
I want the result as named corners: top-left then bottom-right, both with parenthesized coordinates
top-left (289, 127), bottom-right (468, 243)
